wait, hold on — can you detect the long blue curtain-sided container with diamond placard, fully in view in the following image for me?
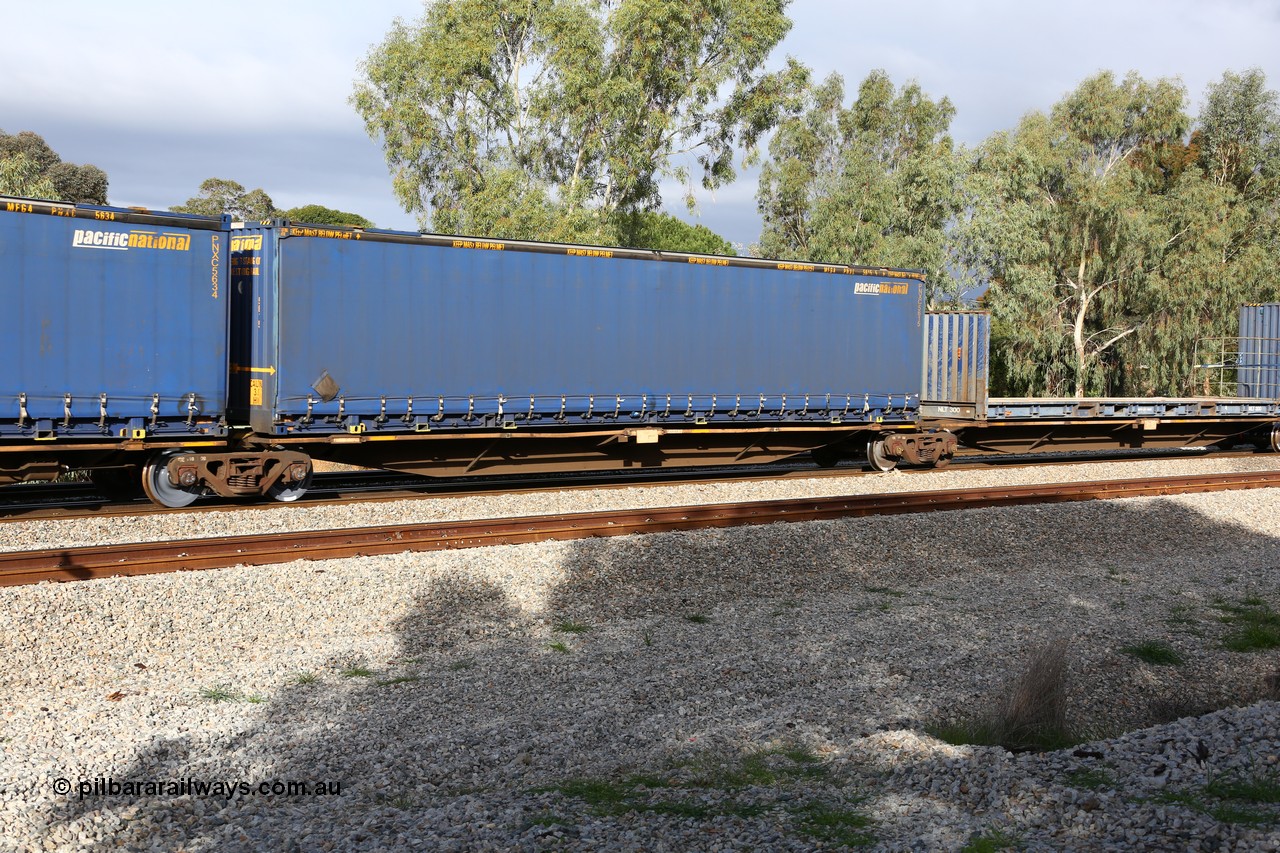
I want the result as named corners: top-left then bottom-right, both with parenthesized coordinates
top-left (232, 225), bottom-right (923, 434)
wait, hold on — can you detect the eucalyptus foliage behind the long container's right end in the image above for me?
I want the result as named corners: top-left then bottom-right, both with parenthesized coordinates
top-left (756, 64), bottom-right (963, 298)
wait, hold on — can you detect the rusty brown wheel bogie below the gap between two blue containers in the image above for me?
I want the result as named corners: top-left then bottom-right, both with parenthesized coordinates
top-left (142, 450), bottom-right (311, 507)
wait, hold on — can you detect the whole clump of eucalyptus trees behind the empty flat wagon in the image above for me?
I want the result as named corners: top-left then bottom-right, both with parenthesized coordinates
top-left (955, 69), bottom-right (1280, 396)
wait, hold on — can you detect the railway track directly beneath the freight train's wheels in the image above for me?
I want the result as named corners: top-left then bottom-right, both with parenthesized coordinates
top-left (0, 450), bottom-right (1262, 524)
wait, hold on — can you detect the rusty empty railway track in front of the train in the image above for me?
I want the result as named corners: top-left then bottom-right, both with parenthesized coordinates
top-left (10, 471), bottom-right (1280, 585)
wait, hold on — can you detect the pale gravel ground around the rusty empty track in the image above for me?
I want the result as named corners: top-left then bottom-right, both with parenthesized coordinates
top-left (0, 460), bottom-right (1280, 850)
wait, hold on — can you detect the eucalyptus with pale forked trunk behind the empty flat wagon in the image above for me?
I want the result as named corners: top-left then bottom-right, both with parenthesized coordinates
top-left (956, 72), bottom-right (1190, 396)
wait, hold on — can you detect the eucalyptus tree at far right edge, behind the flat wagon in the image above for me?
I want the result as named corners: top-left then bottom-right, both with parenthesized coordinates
top-left (1124, 69), bottom-right (1280, 393)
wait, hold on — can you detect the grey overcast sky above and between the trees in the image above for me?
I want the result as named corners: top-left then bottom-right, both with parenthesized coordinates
top-left (0, 0), bottom-right (1280, 243)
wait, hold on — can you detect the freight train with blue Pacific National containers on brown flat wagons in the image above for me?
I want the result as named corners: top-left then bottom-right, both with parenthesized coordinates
top-left (0, 197), bottom-right (1280, 507)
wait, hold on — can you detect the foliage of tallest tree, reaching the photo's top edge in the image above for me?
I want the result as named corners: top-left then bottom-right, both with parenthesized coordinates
top-left (352, 0), bottom-right (791, 237)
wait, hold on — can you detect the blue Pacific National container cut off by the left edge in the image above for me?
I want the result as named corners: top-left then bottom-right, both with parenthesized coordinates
top-left (0, 199), bottom-right (229, 441)
